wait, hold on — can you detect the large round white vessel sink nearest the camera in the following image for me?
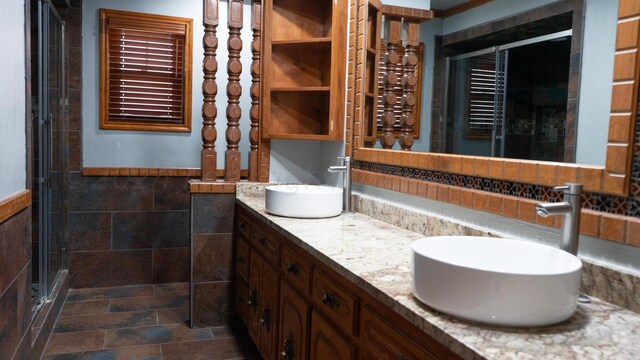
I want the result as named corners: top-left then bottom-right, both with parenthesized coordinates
top-left (411, 236), bottom-right (582, 326)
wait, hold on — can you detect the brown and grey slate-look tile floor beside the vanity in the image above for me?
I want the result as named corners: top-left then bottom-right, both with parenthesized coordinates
top-left (42, 283), bottom-right (260, 360)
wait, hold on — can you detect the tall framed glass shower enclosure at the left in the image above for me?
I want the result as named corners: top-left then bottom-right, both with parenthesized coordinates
top-left (30, 0), bottom-right (68, 316)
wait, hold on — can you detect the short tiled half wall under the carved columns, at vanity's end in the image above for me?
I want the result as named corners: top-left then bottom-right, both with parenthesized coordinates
top-left (191, 193), bottom-right (237, 327)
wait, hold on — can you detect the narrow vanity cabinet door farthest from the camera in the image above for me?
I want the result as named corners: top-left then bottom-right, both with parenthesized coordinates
top-left (247, 249), bottom-right (264, 348)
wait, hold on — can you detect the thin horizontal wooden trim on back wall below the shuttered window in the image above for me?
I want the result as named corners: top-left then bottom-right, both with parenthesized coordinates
top-left (82, 167), bottom-right (249, 181)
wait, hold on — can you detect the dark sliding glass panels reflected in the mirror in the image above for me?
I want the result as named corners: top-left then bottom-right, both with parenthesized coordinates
top-left (438, 30), bottom-right (575, 161)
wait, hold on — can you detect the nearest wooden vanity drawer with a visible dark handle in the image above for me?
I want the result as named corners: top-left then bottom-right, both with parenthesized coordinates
top-left (311, 269), bottom-right (358, 333)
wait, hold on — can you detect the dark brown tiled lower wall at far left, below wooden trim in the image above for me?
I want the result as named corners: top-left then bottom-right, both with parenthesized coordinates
top-left (0, 207), bottom-right (31, 359)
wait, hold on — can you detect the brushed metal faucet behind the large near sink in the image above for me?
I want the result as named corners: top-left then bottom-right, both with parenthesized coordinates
top-left (536, 183), bottom-right (582, 255)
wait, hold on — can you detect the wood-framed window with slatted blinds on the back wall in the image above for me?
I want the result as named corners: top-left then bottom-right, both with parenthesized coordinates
top-left (100, 9), bottom-right (193, 132)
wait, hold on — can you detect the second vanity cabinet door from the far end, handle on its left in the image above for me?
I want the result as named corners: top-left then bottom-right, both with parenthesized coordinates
top-left (260, 262), bottom-right (279, 359)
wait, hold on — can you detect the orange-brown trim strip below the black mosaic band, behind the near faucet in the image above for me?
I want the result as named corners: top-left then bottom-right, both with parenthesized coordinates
top-left (353, 170), bottom-right (640, 247)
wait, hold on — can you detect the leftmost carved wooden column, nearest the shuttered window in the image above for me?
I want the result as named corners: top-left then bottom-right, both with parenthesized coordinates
top-left (200, 0), bottom-right (218, 181)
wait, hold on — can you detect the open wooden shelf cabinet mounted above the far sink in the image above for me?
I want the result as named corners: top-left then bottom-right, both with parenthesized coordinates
top-left (261, 0), bottom-right (348, 140)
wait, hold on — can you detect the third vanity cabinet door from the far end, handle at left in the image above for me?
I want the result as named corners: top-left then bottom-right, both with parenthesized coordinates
top-left (278, 281), bottom-right (309, 360)
